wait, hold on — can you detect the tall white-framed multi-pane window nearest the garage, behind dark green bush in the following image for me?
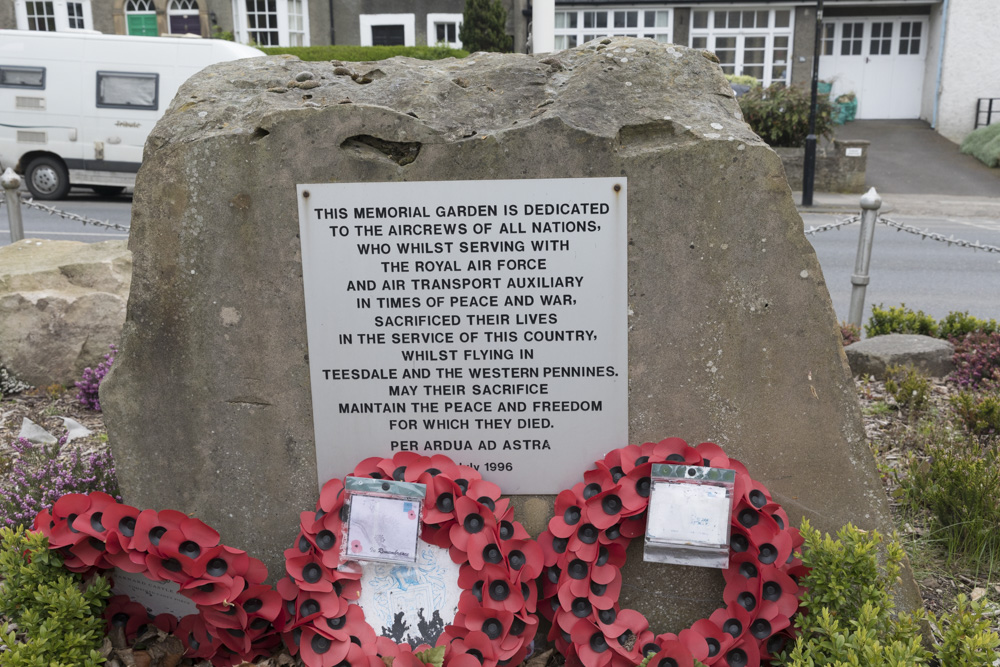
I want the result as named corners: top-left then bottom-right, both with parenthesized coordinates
top-left (690, 9), bottom-right (793, 86)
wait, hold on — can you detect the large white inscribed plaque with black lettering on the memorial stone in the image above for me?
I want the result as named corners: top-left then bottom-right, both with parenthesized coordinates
top-left (298, 178), bottom-right (628, 494)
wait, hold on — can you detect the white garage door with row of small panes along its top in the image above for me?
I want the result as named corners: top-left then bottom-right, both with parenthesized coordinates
top-left (819, 16), bottom-right (928, 118)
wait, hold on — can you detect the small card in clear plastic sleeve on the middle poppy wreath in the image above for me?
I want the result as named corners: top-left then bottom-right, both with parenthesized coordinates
top-left (347, 493), bottom-right (420, 563)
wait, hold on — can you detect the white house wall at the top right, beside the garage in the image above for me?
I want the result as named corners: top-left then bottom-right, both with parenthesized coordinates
top-left (922, 0), bottom-right (1000, 143)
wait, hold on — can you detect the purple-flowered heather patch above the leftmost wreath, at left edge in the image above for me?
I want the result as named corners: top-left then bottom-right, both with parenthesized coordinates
top-left (0, 436), bottom-right (121, 528)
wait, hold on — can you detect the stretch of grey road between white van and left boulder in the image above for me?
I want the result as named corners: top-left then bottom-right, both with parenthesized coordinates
top-left (0, 190), bottom-right (132, 245)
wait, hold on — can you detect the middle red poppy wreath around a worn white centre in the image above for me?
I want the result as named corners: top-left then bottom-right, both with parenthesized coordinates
top-left (277, 452), bottom-right (543, 667)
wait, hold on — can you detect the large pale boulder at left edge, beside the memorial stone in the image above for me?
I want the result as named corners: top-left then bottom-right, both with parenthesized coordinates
top-left (0, 239), bottom-right (132, 386)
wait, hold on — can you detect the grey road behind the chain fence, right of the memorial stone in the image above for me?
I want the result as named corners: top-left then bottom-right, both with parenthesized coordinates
top-left (802, 207), bottom-right (1000, 322)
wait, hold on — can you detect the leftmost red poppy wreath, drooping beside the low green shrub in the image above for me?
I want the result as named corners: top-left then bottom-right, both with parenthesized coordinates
top-left (34, 492), bottom-right (283, 667)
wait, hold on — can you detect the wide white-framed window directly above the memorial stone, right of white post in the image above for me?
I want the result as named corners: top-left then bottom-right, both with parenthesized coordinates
top-left (555, 7), bottom-right (673, 49)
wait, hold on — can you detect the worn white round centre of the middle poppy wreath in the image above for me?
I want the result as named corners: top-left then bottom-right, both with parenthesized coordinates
top-left (358, 540), bottom-right (462, 646)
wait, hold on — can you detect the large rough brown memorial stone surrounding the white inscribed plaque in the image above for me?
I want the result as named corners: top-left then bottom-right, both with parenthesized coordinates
top-left (101, 38), bottom-right (916, 632)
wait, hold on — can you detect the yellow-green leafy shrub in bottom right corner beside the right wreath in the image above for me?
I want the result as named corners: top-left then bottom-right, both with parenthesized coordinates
top-left (776, 520), bottom-right (1000, 667)
